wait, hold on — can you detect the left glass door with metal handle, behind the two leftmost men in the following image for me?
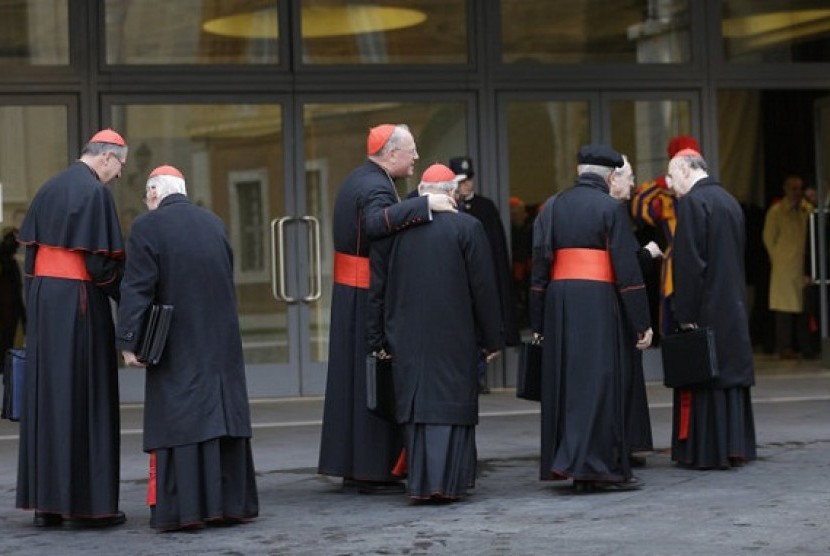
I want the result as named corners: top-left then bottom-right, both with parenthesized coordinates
top-left (109, 99), bottom-right (308, 398)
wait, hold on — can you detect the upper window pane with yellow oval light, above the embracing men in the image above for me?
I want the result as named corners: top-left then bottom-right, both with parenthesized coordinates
top-left (301, 0), bottom-right (468, 64)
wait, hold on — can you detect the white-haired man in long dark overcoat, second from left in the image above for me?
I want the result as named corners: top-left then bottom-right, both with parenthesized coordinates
top-left (117, 165), bottom-right (259, 531)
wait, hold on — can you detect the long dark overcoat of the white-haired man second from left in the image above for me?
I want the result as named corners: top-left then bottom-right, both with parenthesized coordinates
top-left (117, 194), bottom-right (251, 451)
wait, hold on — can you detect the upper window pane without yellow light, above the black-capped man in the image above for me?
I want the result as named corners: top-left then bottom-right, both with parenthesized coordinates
top-left (501, 0), bottom-right (690, 64)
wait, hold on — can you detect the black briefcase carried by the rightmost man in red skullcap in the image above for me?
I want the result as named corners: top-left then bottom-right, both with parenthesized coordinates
top-left (660, 327), bottom-right (718, 388)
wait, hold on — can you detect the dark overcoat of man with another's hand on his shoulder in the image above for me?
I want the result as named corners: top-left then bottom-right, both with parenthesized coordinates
top-left (368, 213), bottom-right (504, 425)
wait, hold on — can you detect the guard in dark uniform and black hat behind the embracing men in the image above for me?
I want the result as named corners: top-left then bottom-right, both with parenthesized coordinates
top-left (449, 156), bottom-right (521, 394)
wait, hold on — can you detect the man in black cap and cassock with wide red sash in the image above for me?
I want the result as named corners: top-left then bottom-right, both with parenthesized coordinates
top-left (530, 145), bottom-right (652, 491)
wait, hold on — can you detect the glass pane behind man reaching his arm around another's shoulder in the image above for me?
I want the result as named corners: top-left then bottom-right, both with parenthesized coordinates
top-left (304, 102), bottom-right (467, 361)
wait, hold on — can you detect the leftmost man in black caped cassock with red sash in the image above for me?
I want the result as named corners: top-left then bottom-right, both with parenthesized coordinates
top-left (17, 129), bottom-right (127, 527)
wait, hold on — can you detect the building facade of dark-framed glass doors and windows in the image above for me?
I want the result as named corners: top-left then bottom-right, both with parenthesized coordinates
top-left (0, 0), bottom-right (830, 397)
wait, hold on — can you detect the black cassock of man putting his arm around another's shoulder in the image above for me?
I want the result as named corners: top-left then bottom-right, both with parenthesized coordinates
top-left (318, 161), bottom-right (430, 481)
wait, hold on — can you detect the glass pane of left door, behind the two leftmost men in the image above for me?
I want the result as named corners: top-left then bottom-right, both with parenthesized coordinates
top-left (113, 104), bottom-right (289, 366)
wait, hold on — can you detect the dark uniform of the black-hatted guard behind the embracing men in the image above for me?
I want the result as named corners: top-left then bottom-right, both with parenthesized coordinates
top-left (461, 195), bottom-right (521, 346)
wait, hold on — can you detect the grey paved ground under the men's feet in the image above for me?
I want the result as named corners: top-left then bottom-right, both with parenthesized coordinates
top-left (0, 358), bottom-right (830, 556)
